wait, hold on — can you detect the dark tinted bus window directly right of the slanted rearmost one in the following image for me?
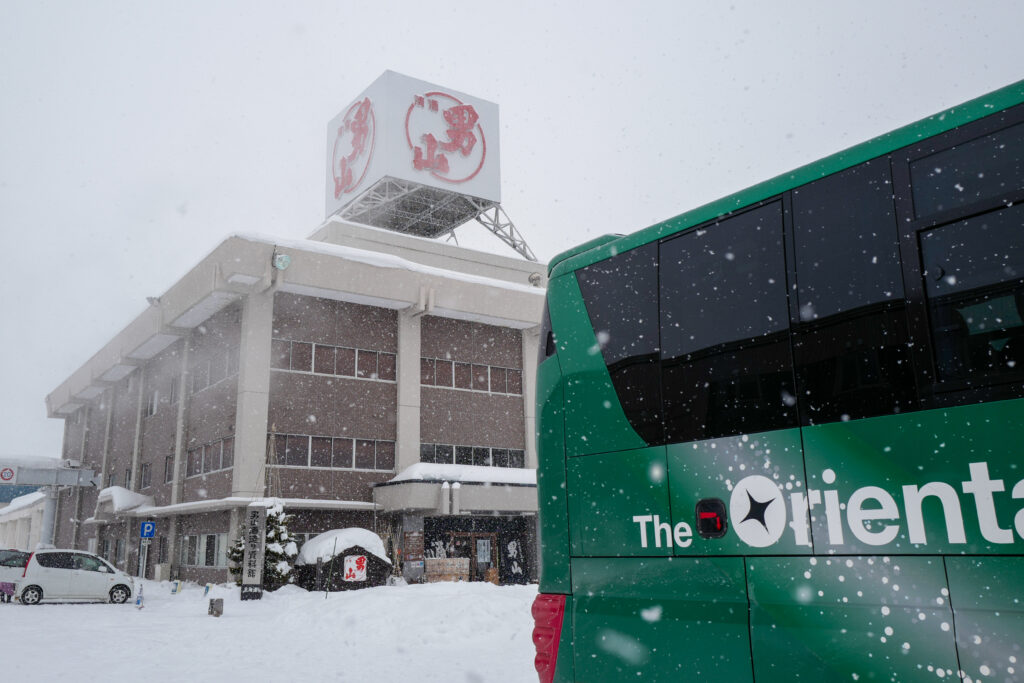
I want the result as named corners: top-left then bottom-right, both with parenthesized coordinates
top-left (659, 202), bottom-right (797, 442)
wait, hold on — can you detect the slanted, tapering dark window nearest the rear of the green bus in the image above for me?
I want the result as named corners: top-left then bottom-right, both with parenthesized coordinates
top-left (577, 244), bottom-right (663, 443)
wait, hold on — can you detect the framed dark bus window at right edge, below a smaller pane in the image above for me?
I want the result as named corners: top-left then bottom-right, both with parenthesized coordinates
top-left (921, 205), bottom-right (1024, 386)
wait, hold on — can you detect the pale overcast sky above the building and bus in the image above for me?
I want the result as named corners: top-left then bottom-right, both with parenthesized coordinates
top-left (0, 0), bottom-right (1024, 457)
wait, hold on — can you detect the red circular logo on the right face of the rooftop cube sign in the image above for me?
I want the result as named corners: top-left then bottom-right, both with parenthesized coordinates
top-left (406, 92), bottom-right (487, 187)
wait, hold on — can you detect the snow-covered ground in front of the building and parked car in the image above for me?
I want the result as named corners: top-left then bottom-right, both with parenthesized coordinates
top-left (0, 581), bottom-right (537, 683)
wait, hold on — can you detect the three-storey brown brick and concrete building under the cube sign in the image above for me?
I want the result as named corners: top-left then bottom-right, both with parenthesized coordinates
top-left (46, 218), bottom-right (546, 582)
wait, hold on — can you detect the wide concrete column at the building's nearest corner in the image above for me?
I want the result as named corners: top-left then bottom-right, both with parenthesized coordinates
top-left (231, 290), bottom-right (273, 498)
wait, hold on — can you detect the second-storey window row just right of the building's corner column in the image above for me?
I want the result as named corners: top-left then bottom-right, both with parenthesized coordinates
top-left (268, 434), bottom-right (394, 472)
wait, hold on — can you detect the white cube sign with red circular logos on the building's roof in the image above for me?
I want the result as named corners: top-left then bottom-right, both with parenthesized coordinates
top-left (319, 71), bottom-right (501, 216)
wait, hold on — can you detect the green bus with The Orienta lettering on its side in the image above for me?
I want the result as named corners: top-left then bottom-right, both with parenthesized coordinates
top-left (532, 81), bottom-right (1024, 683)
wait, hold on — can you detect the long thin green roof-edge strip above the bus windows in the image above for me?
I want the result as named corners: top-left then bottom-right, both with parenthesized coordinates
top-left (550, 81), bottom-right (1024, 278)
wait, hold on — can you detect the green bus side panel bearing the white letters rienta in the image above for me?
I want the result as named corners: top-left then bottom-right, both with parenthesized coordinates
top-left (803, 399), bottom-right (1024, 555)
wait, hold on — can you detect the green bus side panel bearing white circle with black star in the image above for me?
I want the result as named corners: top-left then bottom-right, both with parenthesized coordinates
top-left (663, 429), bottom-right (811, 555)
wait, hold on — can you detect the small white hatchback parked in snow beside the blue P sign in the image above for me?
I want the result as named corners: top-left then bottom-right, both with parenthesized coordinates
top-left (14, 549), bottom-right (135, 605)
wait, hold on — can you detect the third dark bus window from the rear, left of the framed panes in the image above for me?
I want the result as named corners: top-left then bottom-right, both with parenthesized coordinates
top-left (793, 159), bottom-right (916, 425)
